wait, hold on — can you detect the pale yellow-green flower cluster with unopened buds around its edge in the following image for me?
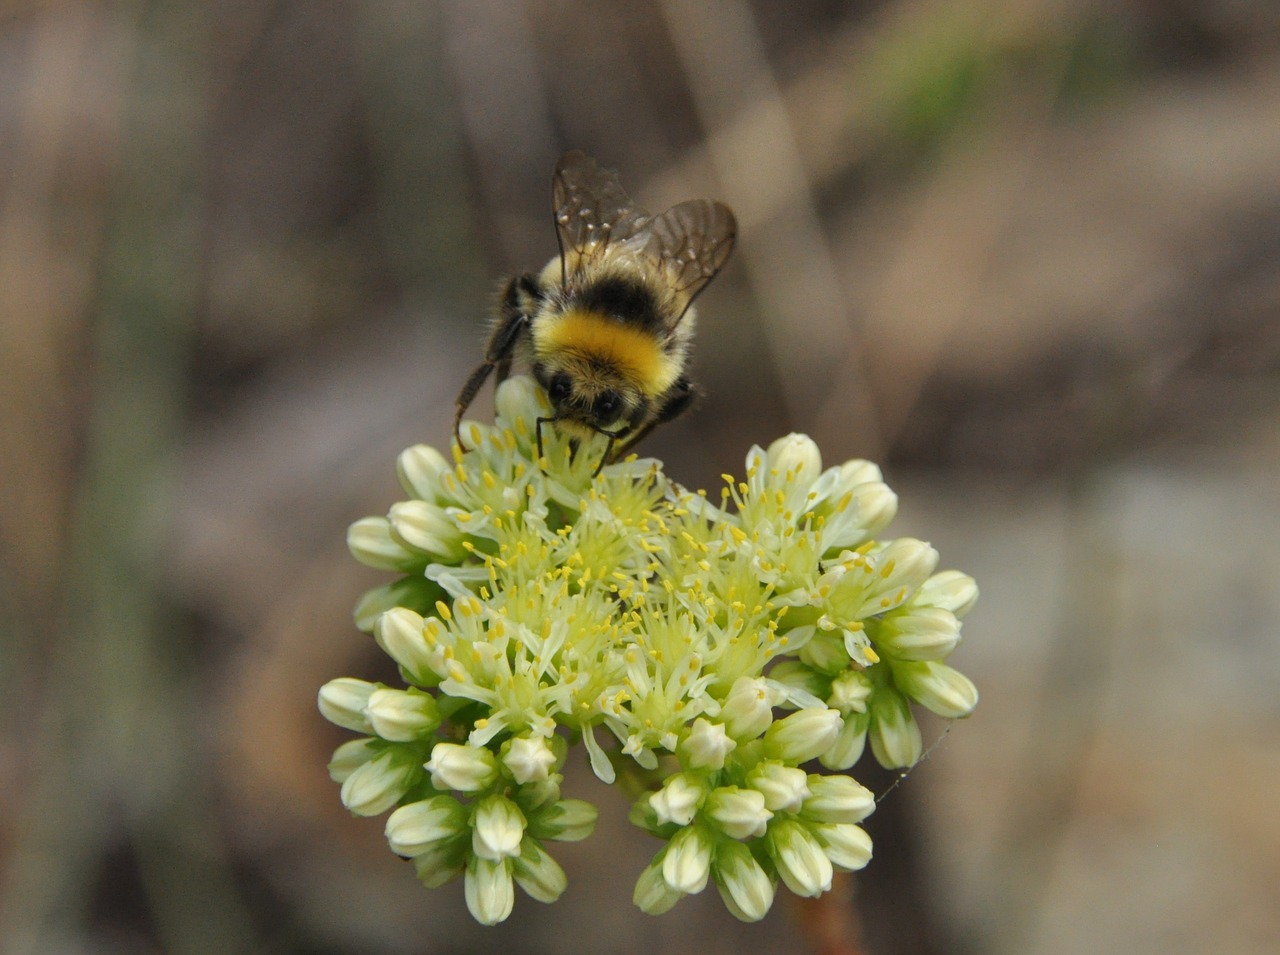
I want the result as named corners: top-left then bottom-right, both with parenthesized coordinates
top-left (320, 378), bottom-right (978, 924)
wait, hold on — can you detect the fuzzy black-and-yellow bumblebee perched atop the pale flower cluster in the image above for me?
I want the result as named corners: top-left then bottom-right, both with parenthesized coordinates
top-left (453, 150), bottom-right (737, 471)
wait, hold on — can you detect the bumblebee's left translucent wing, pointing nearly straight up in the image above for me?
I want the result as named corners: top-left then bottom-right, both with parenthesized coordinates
top-left (552, 150), bottom-right (652, 278)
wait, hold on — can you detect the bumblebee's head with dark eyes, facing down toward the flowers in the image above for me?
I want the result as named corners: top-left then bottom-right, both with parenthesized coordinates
top-left (532, 356), bottom-right (646, 437)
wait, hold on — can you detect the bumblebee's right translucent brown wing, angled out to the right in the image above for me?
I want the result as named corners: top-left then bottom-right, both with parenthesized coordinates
top-left (646, 198), bottom-right (737, 323)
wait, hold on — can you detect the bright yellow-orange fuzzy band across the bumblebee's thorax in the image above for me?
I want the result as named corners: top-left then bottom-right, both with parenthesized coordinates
top-left (531, 310), bottom-right (680, 397)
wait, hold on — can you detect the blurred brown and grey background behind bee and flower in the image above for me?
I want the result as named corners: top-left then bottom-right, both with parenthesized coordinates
top-left (0, 0), bottom-right (1280, 955)
